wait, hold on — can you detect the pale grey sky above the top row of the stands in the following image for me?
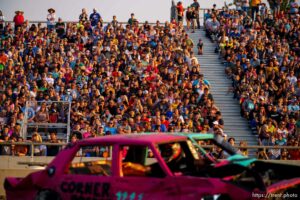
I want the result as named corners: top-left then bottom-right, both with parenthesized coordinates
top-left (0, 0), bottom-right (229, 22)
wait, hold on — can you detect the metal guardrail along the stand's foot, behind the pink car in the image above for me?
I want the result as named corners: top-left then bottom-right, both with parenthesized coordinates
top-left (0, 142), bottom-right (300, 158)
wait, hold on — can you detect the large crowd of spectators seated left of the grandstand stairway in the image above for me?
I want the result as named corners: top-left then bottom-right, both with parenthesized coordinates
top-left (0, 8), bottom-right (223, 155)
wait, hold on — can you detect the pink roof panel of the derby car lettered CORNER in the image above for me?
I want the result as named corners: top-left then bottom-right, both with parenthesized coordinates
top-left (78, 133), bottom-right (187, 145)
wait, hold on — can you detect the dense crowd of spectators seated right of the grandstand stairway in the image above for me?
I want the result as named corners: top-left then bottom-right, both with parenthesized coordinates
top-left (205, 1), bottom-right (300, 159)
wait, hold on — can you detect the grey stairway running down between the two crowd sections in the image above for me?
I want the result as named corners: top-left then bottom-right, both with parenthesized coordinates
top-left (189, 28), bottom-right (257, 156)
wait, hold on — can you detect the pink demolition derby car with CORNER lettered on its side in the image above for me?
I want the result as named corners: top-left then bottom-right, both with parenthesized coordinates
top-left (4, 134), bottom-right (300, 200)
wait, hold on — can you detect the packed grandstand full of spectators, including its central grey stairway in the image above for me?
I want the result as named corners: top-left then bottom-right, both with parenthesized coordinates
top-left (0, 2), bottom-right (300, 159)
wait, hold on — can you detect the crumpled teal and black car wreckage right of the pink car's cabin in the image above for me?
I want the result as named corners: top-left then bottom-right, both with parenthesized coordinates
top-left (142, 133), bottom-right (300, 194)
